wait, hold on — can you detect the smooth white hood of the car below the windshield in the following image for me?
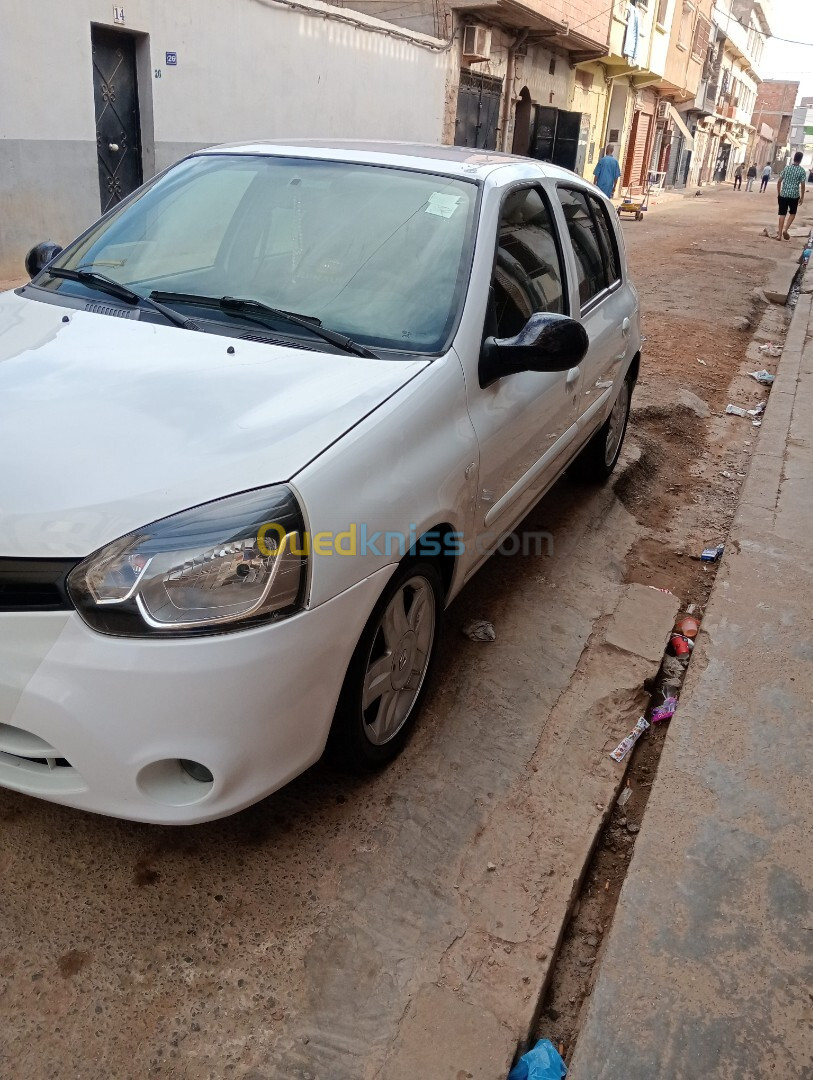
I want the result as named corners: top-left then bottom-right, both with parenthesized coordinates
top-left (0, 293), bottom-right (428, 557)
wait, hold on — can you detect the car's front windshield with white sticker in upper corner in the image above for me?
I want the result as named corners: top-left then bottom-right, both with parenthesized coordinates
top-left (44, 153), bottom-right (477, 353)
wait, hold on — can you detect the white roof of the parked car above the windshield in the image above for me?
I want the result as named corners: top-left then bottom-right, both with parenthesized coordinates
top-left (193, 139), bottom-right (586, 183)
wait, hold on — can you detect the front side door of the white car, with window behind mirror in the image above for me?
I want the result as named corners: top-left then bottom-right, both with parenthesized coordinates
top-left (459, 183), bottom-right (581, 554)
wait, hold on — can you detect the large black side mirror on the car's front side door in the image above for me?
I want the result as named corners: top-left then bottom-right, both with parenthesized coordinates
top-left (479, 311), bottom-right (590, 387)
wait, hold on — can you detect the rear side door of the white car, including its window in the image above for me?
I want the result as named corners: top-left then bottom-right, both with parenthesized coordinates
top-left (557, 184), bottom-right (633, 442)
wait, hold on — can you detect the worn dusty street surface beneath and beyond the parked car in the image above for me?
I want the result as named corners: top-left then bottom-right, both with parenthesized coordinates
top-left (0, 186), bottom-right (807, 1080)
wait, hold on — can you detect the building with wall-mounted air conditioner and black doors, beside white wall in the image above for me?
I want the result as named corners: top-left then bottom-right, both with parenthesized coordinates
top-left (338, 0), bottom-right (610, 175)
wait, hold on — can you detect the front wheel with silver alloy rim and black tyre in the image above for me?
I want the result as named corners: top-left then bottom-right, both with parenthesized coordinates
top-left (327, 558), bottom-right (444, 772)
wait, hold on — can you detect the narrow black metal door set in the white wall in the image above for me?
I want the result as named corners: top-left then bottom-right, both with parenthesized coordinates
top-left (91, 26), bottom-right (141, 214)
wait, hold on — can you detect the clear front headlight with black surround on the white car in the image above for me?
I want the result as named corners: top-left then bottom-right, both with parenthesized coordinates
top-left (68, 485), bottom-right (307, 637)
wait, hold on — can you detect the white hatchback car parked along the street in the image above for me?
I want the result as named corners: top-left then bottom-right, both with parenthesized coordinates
top-left (0, 143), bottom-right (640, 823)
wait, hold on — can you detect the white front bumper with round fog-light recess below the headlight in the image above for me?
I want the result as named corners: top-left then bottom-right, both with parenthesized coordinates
top-left (0, 567), bottom-right (393, 824)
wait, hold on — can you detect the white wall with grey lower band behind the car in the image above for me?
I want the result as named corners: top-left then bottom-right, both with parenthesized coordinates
top-left (0, 0), bottom-right (450, 278)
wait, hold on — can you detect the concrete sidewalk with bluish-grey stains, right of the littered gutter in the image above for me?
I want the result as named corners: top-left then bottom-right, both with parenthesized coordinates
top-left (569, 294), bottom-right (813, 1080)
